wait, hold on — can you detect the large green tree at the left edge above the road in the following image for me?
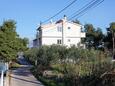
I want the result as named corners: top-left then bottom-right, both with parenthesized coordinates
top-left (0, 20), bottom-right (26, 61)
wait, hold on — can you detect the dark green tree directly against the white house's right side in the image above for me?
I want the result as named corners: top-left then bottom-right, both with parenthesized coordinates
top-left (84, 24), bottom-right (104, 48)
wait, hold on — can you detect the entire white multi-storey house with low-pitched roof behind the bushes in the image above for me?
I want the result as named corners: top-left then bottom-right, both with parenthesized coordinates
top-left (33, 17), bottom-right (85, 47)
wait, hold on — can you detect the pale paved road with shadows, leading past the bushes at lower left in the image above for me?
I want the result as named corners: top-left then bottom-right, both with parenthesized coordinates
top-left (10, 59), bottom-right (43, 86)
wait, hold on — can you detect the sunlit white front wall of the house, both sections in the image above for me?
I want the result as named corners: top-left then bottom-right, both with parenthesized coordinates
top-left (38, 22), bottom-right (85, 46)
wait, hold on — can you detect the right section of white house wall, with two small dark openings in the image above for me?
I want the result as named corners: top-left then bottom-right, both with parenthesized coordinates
top-left (64, 22), bottom-right (81, 46)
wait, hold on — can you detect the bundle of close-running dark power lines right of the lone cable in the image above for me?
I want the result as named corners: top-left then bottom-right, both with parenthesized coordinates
top-left (70, 0), bottom-right (104, 20)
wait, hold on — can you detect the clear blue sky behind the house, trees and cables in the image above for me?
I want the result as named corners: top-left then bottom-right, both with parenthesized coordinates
top-left (0, 0), bottom-right (115, 39)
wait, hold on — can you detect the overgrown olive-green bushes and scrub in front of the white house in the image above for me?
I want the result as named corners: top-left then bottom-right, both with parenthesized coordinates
top-left (25, 45), bottom-right (114, 86)
